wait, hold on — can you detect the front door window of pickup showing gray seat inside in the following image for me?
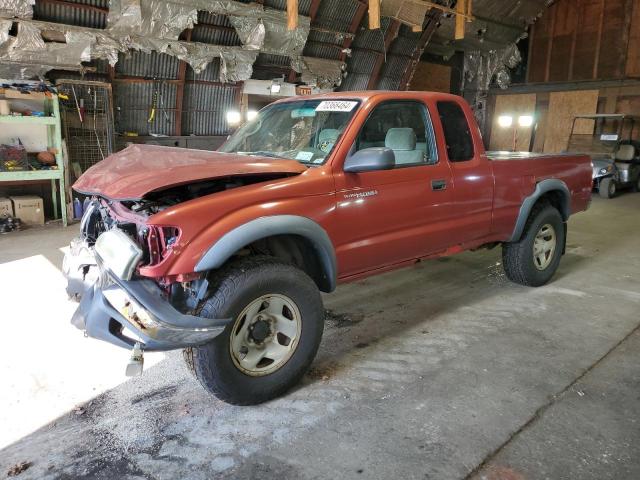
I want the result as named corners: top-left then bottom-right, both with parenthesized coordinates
top-left (356, 101), bottom-right (438, 168)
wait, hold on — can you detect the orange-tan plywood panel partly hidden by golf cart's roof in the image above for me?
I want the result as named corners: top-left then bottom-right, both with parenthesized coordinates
top-left (544, 90), bottom-right (599, 153)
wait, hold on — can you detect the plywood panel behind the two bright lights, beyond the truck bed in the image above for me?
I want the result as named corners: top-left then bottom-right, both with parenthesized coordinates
top-left (489, 93), bottom-right (536, 151)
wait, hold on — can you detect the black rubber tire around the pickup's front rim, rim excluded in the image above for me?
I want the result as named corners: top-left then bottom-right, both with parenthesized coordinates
top-left (184, 256), bottom-right (324, 405)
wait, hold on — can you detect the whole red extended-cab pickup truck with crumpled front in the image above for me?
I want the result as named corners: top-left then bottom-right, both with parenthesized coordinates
top-left (64, 92), bottom-right (591, 404)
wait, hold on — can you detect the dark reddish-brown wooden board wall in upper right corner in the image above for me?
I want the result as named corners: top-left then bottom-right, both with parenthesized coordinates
top-left (527, 0), bottom-right (640, 83)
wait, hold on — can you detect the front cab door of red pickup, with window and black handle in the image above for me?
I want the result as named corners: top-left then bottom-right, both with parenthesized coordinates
top-left (334, 100), bottom-right (453, 277)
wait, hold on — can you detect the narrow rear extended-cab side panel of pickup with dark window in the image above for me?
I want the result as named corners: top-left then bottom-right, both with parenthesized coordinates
top-left (436, 100), bottom-right (494, 245)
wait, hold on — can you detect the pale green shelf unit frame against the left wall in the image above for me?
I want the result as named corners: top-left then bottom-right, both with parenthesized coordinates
top-left (0, 94), bottom-right (67, 227)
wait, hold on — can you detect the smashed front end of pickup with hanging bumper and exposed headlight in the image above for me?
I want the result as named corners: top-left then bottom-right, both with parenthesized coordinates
top-left (63, 198), bottom-right (229, 351)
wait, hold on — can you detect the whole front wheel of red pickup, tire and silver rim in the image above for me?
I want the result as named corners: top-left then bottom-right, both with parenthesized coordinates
top-left (184, 257), bottom-right (324, 405)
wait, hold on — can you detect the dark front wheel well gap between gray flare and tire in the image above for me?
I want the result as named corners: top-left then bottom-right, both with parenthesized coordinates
top-left (234, 234), bottom-right (332, 292)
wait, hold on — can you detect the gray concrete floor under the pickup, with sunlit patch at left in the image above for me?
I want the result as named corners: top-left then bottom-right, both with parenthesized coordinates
top-left (0, 194), bottom-right (640, 480)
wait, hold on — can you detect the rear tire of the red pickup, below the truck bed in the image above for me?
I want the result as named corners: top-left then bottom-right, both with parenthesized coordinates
top-left (502, 203), bottom-right (565, 287)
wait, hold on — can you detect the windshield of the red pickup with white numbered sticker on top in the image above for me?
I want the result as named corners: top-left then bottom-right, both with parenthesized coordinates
top-left (220, 100), bottom-right (359, 165)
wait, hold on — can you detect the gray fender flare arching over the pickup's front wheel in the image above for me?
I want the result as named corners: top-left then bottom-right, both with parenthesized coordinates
top-left (195, 215), bottom-right (338, 292)
